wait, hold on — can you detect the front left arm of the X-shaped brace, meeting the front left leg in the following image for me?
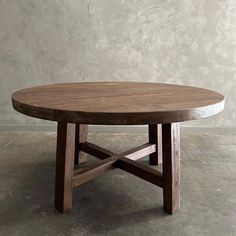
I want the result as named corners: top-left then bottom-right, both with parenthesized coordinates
top-left (73, 157), bottom-right (117, 187)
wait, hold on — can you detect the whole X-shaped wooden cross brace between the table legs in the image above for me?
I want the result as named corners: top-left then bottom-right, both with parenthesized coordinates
top-left (77, 142), bottom-right (163, 187)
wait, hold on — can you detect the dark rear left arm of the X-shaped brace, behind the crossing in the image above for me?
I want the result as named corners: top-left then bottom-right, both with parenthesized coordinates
top-left (80, 142), bottom-right (115, 160)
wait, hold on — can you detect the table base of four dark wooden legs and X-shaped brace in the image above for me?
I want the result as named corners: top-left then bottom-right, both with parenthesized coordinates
top-left (55, 122), bottom-right (180, 214)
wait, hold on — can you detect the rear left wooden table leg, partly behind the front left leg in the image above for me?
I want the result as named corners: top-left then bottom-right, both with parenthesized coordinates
top-left (74, 124), bottom-right (88, 165)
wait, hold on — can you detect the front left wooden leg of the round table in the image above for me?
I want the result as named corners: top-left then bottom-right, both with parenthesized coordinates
top-left (55, 122), bottom-right (76, 213)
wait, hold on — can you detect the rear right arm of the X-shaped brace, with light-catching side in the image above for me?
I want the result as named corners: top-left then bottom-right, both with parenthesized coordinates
top-left (120, 143), bottom-right (156, 161)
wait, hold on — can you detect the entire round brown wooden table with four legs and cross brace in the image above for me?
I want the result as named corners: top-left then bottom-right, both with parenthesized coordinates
top-left (12, 82), bottom-right (224, 214)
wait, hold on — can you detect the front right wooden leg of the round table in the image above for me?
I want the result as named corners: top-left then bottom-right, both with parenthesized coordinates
top-left (162, 123), bottom-right (180, 214)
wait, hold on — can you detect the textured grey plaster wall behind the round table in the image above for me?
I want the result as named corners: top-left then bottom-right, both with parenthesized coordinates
top-left (0, 0), bottom-right (236, 126)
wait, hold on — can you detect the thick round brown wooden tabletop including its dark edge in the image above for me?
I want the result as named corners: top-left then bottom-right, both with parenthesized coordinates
top-left (12, 82), bottom-right (224, 125)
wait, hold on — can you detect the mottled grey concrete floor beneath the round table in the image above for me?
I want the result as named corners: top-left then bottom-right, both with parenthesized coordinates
top-left (0, 132), bottom-right (236, 236)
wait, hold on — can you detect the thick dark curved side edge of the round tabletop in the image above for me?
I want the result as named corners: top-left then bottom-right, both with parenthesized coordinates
top-left (12, 93), bottom-right (225, 125)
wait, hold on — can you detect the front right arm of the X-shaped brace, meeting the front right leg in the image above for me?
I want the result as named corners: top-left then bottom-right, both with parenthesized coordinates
top-left (118, 157), bottom-right (163, 187)
